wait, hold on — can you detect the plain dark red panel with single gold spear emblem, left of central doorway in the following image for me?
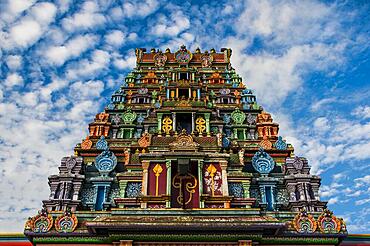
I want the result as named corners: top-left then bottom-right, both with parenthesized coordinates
top-left (148, 163), bottom-right (167, 196)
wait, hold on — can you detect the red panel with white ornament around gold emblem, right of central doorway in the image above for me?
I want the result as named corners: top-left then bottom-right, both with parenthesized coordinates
top-left (203, 163), bottom-right (222, 196)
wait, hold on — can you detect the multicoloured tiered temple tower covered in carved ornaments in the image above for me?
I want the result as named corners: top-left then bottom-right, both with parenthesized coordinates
top-left (24, 46), bottom-right (347, 246)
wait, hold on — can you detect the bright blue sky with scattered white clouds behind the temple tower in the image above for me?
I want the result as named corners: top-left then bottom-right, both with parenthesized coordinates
top-left (0, 0), bottom-right (370, 233)
